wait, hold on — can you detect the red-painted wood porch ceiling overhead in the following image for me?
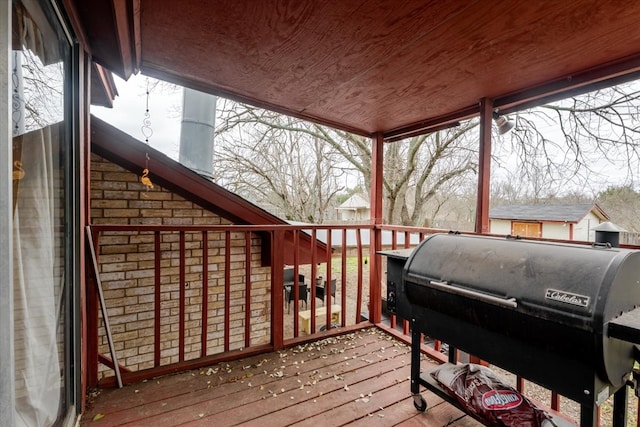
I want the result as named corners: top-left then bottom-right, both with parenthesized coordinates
top-left (72, 0), bottom-right (640, 140)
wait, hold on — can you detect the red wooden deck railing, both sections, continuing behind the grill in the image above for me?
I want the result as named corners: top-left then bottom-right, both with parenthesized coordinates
top-left (88, 225), bottom-right (640, 426)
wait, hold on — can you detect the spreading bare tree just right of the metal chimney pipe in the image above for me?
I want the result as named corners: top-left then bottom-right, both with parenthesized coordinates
top-left (214, 103), bottom-right (345, 223)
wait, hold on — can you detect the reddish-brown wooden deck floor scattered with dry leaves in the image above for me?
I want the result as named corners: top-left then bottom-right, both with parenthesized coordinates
top-left (81, 328), bottom-right (480, 427)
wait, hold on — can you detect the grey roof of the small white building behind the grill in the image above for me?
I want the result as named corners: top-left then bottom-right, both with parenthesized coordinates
top-left (489, 203), bottom-right (609, 223)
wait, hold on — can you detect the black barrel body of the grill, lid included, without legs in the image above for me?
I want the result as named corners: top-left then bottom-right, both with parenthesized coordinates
top-left (396, 234), bottom-right (640, 424)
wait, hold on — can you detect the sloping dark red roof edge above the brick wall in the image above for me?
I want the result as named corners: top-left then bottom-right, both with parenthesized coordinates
top-left (91, 116), bottom-right (326, 264)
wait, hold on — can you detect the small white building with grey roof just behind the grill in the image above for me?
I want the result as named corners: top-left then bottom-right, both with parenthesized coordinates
top-left (489, 203), bottom-right (609, 241)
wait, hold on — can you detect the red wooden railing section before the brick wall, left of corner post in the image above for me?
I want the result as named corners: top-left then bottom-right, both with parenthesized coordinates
top-left (88, 225), bottom-right (371, 386)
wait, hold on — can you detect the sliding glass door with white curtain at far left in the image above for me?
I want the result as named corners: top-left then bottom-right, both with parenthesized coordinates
top-left (10, 0), bottom-right (77, 427)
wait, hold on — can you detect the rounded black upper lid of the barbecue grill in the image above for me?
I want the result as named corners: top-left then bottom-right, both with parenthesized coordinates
top-left (404, 234), bottom-right (640, 330)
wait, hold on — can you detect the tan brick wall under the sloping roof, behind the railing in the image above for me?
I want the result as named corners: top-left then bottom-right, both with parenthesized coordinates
top-left (91, 154), bottom-right (270, 375)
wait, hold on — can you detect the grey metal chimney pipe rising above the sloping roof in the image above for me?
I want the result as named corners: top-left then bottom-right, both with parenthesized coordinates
top-left (179, 88), bottom-right (217, 178)
